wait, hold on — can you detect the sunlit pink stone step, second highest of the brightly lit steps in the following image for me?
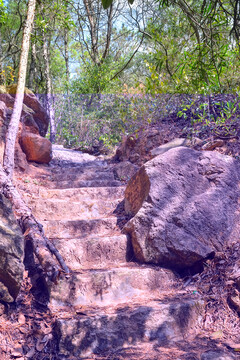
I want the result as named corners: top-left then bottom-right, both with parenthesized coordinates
top-left (27, 198), bottom-right (120, 220)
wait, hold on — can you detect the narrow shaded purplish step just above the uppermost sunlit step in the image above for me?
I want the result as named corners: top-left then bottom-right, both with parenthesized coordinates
top-left (49, 179), bottom-right (122, 189)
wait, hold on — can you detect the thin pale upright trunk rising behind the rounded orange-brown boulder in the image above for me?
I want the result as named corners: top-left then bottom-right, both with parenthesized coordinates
top-left (42, 30), bottom-right (56, 143)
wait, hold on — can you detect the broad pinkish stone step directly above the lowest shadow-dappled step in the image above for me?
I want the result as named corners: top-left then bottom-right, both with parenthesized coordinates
top-left (50, 264), bottom-right (176, 307)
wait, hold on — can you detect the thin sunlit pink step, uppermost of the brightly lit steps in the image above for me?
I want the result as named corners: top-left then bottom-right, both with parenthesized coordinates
top-left (36, 186), bottom-right (126, 201)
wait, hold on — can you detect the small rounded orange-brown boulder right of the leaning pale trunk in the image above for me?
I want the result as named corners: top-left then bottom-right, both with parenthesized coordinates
top-left (20, 132), bottom-right (52, 164)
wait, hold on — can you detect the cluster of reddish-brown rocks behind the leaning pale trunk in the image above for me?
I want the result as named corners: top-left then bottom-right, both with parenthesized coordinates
top-left (0, 85), bottom-right (52, 170)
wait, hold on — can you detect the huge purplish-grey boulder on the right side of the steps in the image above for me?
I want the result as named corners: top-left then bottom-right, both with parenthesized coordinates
top-left (125, 147), bottom-right (239, 270)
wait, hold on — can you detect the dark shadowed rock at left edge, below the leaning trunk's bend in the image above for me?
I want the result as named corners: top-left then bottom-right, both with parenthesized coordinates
top-left (0, 196), bottom-right (24, 302)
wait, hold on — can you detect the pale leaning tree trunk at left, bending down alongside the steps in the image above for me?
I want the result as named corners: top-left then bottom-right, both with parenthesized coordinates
top-left (0, 0), bottom-right (69, 281)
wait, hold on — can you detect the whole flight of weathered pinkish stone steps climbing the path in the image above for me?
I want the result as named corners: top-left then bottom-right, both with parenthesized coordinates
top-left (22, 154), bottom-right (202, 359)
